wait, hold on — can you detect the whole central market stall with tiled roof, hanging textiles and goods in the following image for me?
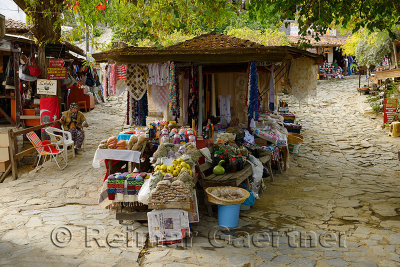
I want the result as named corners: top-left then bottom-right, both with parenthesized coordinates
top-left (93, 33), bottom-right (322, 242)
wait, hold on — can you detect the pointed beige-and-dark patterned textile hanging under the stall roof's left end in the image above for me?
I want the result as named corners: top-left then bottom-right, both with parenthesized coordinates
top-left (126, 64), bottom-right (149, 100)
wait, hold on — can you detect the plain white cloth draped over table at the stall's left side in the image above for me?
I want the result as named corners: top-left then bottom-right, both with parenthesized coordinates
top-left (92, 148), bottom-right (141, 168)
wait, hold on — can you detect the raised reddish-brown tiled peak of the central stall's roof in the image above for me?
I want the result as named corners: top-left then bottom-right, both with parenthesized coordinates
top-left (169, 32), bottom-right (264, 50)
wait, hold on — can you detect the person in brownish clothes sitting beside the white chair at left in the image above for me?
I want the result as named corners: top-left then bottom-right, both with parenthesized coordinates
top-left (61, 103), bottom-right (89, 153)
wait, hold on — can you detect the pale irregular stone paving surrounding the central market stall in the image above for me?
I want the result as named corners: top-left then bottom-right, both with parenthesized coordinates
top-left (0, 79), bottom-right (400, 266)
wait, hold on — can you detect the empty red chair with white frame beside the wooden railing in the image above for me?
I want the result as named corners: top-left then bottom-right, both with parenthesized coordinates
top-left (26, 131), bottom-right (68, 170)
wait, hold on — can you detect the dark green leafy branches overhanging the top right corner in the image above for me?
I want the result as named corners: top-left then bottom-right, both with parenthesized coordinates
top-left (255, 0), bottom-right (400, 37)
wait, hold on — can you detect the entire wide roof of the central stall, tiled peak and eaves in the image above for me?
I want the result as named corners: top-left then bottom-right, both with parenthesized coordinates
top-left (93, 32), bottom-right (323, 64)
